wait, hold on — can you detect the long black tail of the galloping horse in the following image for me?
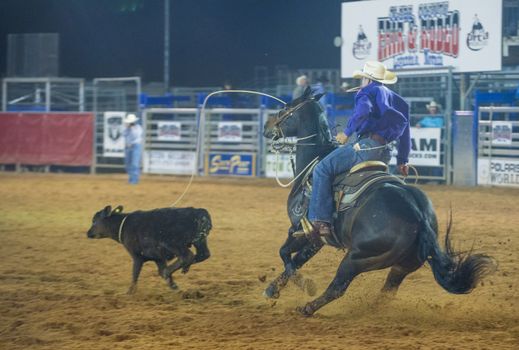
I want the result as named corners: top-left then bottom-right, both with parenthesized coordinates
top-left (406, 188), bottom-right (496, 294)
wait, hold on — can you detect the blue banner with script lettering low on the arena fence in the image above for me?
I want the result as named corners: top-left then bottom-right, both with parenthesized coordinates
top-left (205, 153), bottom-right (256, 176)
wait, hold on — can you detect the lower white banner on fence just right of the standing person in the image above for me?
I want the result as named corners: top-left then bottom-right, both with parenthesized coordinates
top-left (143, 151), bottom-right (196, 175)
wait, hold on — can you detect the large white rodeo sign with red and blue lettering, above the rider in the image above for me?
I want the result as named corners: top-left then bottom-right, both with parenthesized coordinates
top-left (341, 0), bottom-right (503, 78)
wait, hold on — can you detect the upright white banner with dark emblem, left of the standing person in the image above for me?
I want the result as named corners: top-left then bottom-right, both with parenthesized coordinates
top-left (103, 112), bottom-right (126, 157)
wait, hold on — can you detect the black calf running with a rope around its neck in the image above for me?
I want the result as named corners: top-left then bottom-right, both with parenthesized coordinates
top-left (87, 206), bottom-right (212, 294)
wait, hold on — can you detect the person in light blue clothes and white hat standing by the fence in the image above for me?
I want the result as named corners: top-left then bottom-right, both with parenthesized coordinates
top-left (123, 114), bottom-right (142, 185)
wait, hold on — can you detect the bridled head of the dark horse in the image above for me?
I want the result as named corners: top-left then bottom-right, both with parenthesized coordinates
top-left (263, 88), bottom-right (329, 140)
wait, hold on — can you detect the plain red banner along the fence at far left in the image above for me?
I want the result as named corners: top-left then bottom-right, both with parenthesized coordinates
top-left (0, 113), bottom-right (94, 166)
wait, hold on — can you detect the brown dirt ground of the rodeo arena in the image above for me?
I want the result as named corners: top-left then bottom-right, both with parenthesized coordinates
top-left (0, 173), bottom-right (519, 350)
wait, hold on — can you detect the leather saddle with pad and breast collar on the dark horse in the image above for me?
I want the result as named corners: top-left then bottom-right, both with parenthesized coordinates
top-left (300, 161), bottom-right (404, 248)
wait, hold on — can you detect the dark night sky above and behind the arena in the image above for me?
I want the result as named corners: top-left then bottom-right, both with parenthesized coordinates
top-left (0, 0), bottom-right (360, 86)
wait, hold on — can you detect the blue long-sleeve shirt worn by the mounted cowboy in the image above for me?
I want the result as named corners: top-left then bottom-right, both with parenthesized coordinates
top-left (344, 82), bottom-right (411, 164)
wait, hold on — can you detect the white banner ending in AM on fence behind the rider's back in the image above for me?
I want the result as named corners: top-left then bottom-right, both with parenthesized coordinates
top-left (391, 128), bottom-right (442, 166)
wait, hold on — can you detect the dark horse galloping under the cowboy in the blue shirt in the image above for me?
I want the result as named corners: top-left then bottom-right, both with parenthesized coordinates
top-left (263, 91), bottom-right (495, 316)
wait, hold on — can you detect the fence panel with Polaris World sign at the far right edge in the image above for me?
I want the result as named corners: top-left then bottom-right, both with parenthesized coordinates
top-left (477, 107), bottom-right (519, 187)
